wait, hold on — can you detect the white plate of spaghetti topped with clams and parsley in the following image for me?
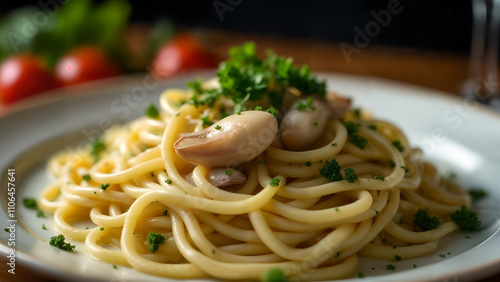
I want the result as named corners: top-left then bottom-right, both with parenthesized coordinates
top-left (0, 43), bottom-right (500, 281)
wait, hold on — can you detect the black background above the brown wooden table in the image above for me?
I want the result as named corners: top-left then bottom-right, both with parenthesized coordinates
top-left (0, 0), bottom-right (472, 53)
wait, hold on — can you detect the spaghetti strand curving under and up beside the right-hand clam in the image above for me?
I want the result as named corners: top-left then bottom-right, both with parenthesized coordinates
top-left (266, 120), bottom-right (347, 163)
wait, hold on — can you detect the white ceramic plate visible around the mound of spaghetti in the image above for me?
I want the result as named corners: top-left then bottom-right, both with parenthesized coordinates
top-left (0, 73), bottom-right (500, 281)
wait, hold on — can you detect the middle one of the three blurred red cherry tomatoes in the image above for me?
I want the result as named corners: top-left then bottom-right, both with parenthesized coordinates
top-left (56, 46), bottom-right (121, 85)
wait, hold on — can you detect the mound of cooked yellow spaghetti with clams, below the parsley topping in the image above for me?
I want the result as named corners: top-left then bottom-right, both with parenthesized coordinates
top-left (38, 43), bottom-right (471, 280)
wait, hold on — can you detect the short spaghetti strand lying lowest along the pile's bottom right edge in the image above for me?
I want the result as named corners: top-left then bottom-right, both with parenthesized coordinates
top-left (358, 240), bottom-right (439, 260)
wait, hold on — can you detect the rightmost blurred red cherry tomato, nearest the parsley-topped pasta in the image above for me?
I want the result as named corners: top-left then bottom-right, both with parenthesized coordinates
top-left (153, 35), bottom-right (217, 77)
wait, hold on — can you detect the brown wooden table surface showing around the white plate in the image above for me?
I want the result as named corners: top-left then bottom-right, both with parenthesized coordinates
top-left (0, 30), bottom-right (500, 282)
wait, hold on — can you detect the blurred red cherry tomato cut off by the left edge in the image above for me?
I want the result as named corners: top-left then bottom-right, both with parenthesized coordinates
top-left (0, 54), bottom-right (58, 104)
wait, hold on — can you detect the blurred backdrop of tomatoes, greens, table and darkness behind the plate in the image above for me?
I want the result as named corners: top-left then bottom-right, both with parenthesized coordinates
top-left (0, 0), bottom-right (488, 104)
